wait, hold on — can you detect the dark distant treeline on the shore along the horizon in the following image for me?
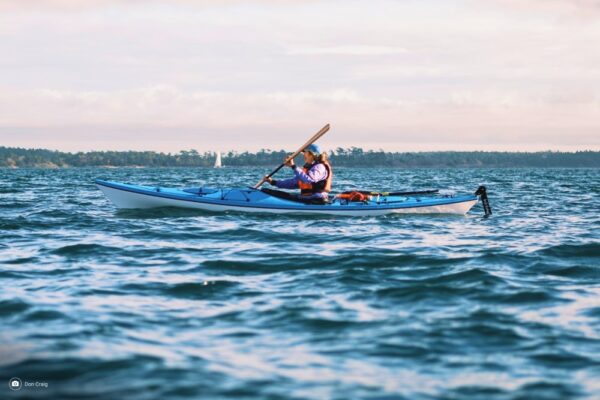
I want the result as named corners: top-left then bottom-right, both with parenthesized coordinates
top-left (0, 147), bottom-right (600, 168)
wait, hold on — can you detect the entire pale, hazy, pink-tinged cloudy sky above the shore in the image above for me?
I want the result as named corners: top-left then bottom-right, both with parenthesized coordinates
top-left (0, 0), bottom-right (600, 152)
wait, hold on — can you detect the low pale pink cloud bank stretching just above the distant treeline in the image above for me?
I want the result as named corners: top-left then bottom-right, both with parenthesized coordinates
top-left (0, 85), bottom-right (600, 151)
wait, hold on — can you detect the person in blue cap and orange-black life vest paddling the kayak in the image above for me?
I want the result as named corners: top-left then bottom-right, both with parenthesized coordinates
top-left (266, 143), bottom-right (333, 204)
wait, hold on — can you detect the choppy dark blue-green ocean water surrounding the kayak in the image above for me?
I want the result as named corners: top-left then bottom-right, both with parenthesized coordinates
top-left (0, 168), bottom-right (600, 399)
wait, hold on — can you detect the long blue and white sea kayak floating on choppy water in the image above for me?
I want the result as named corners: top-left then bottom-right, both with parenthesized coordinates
top-left (95, 180), bottom-right (487, 216)
